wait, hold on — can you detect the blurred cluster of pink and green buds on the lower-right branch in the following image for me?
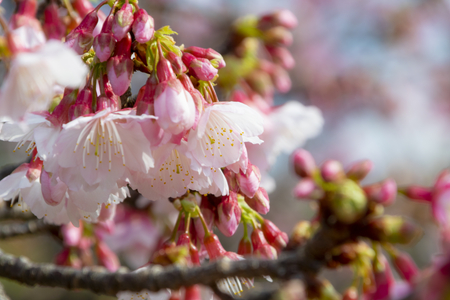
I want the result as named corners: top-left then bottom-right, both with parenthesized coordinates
top-left (289, 149), bottom-right (424, 299)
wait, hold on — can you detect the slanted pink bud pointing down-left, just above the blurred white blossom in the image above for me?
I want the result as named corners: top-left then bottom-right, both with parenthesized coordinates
top-left (65, 10), bottom-right (98, 55)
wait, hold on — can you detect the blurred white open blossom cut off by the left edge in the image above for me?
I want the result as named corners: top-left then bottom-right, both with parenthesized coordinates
top-left (0, 40), bottom-right (87, 121)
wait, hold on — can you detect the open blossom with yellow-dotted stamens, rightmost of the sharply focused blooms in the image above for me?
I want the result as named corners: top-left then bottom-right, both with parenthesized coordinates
top-left (188, 102), bottom-right (263, 168)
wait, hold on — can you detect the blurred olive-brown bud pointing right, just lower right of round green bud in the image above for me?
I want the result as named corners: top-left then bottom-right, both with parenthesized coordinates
top-left (365, 216), bottom-right (422, 244)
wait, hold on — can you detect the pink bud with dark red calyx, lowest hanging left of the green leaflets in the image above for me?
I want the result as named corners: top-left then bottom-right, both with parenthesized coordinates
top-left (106, 34), bottom-right (133, 96)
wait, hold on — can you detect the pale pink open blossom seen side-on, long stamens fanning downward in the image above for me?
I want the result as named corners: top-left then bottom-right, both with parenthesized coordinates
top-left (53, 109), bottom-right (154, 190)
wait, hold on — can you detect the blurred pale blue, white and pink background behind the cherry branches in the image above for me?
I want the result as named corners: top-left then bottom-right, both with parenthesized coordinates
top-left (0, 0), bottom-right (450, 300)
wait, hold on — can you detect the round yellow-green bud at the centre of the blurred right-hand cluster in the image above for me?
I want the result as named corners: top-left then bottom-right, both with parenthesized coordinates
top-left (325, 179), bottom-right (367, 224)
